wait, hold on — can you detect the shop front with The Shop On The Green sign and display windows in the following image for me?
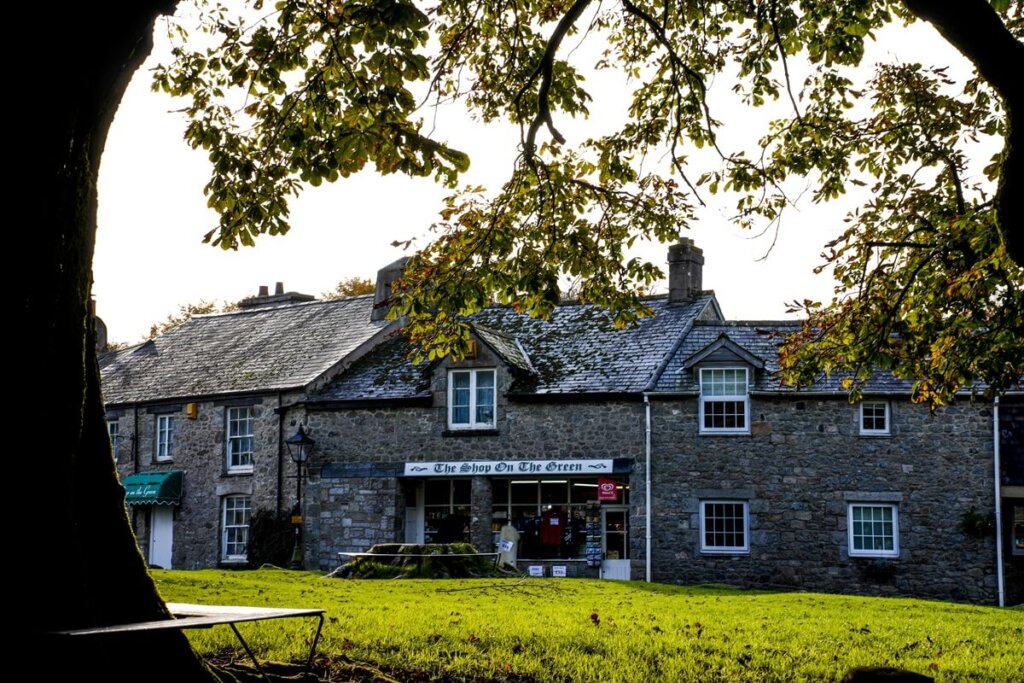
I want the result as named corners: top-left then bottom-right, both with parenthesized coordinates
top-left (403, 459), bottom-right (632, 580)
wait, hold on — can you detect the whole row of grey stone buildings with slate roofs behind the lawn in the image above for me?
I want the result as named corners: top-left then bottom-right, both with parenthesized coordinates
top-left (102, 240), bottom-right (1024, 603)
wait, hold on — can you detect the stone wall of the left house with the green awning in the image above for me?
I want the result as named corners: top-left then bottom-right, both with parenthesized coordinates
top-left (108, 395), bottom-right (295, 569)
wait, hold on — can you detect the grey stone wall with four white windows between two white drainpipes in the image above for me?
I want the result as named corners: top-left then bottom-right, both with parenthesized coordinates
top-left (651, 397), bottom-right (995, 603)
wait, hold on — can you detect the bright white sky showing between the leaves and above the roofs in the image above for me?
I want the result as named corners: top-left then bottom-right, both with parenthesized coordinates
top-left (93, 8), bottom-right (983, 342)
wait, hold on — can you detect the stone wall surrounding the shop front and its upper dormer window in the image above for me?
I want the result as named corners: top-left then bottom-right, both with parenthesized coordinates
top-left (300, 349), bottom-right (644, 575)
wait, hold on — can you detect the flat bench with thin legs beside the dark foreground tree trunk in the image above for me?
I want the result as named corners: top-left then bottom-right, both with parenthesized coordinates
top-left (48, 602), bottom-right (324, 679)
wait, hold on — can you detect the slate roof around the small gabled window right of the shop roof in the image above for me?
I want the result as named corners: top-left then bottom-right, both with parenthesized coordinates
top-left (654, 321), bottom-right (911, 394)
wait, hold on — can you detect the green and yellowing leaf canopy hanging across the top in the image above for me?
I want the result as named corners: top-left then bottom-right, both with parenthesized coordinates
top-left (155, 0), bottom-right (1024, 405)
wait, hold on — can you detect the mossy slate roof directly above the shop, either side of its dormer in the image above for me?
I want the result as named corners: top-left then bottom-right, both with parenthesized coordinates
top-left (313, 294), bottom-right (718, 400)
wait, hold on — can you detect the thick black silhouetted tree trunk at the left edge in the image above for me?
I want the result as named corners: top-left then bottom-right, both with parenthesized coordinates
top-left (23, 0), bottom-right (211, 681)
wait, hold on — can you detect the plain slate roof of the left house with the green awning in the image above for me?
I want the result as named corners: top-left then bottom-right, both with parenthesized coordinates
top-left (100, 296), bottom-right (389, 404)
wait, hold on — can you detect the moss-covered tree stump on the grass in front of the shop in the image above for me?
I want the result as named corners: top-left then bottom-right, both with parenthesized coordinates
top-left (330, 543), bottom-right (514, 579)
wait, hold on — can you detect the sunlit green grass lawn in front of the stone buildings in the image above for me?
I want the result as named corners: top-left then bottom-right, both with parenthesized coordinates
top-left (153, 569), bottom-right (1024, 683)
